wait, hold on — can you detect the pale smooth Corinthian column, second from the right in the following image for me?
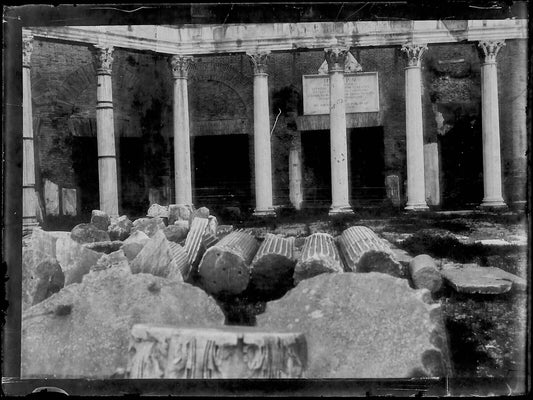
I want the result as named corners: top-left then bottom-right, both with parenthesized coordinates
top-left (402, 44), bottom-right (428, 210)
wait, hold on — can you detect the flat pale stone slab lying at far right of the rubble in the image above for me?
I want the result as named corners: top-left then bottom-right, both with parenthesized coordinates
top-left (441, 264), bottom-right (527, 294)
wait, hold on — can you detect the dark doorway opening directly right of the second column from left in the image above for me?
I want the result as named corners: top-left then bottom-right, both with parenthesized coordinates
top-left (120, 137), bottom-right (149, 216)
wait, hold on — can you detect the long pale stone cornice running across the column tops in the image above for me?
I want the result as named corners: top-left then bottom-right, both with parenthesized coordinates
top-left (23, 19), bottom-right (527, 55)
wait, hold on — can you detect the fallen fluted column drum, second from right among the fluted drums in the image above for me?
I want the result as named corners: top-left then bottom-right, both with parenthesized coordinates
top-left (293, 233), bottom-right (344, 284)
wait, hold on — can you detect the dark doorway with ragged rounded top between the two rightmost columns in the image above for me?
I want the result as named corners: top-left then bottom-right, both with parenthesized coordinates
top-left (439, 115), bottom-right (483, 209)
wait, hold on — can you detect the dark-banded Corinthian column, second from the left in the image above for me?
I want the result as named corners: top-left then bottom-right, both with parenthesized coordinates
top-left (94, 46), bottom-right (118, 217)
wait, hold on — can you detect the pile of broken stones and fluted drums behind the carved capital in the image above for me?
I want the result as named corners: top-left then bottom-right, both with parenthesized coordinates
top-left (22, 204), bottom-right (525, 378)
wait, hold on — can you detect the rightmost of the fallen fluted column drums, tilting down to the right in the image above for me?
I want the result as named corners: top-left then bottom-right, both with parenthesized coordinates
top-left (337, 226), bottom-right (403, 277)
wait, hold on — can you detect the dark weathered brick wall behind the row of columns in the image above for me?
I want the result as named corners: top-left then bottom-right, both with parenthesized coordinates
top-left (31, 40), bottom-right (527, 219)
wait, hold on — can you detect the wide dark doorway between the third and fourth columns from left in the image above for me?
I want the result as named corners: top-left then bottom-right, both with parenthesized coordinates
top-left (192, 135), bottom-right (252, 209)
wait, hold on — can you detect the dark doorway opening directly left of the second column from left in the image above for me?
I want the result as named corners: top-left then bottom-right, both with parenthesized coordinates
top-left (72, 136), bottom-right (100, 220)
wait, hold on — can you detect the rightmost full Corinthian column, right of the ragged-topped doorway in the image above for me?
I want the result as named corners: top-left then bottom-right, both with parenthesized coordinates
top-left (479, 41), bottom-right (507, 208)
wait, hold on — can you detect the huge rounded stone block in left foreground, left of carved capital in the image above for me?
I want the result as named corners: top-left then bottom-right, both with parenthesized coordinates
top-left (21, 268), bottom-right (224, 379)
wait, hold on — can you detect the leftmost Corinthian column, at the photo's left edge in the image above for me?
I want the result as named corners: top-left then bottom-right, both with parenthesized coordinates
top-left (22, 36), bottom-right (39, 234)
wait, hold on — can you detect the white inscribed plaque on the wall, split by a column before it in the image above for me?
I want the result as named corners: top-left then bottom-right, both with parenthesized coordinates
top-left (302, 72), bottom-right (379, 115)
